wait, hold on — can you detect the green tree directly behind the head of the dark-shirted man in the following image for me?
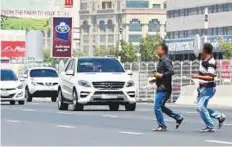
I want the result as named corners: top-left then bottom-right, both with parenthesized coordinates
top-left (140, 35), bottom-right (163, 61)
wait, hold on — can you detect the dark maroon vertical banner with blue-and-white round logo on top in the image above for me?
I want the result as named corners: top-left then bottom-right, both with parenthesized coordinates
top-left (52, 17), bottom-right (72, 58)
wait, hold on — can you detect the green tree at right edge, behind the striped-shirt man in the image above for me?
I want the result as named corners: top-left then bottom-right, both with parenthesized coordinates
top-left (219, 40), bottom-right (232, 59)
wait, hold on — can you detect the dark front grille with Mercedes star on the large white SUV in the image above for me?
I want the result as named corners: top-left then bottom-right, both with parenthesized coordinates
top-left (93, 82), bottom-right (125, 90)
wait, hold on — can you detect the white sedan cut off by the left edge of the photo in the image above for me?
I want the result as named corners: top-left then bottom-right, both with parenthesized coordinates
top-left (0, 69), bottom-right (25, 105)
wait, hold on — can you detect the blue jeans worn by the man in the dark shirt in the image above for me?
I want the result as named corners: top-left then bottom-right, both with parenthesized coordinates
top-left (154, 92), bottom-right (182, 128)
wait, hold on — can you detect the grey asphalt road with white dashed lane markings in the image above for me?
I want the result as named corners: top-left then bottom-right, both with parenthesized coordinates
top-left (1, 102), bottom-right (232, 146)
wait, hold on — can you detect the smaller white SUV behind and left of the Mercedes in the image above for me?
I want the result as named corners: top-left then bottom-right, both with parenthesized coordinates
top-left (24, 67), bottom-right (59, 102)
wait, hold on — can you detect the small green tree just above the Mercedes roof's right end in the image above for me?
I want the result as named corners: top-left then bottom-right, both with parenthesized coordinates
top-left (120, 41), bottom-right (136, 62)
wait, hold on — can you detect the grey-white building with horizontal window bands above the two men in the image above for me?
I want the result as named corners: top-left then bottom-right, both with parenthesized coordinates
top-left (166, 0), bottom-right (232, 60)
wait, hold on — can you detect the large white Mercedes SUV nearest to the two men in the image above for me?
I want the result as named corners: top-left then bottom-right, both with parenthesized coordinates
top-left (57, 57), bottom-right (136, 111)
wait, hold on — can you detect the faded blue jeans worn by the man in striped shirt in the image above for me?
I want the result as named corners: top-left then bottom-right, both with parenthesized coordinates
top-left (197, 88), bottom-right (222, 129)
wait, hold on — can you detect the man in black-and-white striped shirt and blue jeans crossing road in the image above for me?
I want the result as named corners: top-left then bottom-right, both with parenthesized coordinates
top-left (192, 43), bottom-right (225, 132)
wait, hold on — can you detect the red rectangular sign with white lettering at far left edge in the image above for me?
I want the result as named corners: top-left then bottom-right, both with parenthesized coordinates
top-left (1, 41), bottom-right (26, 57)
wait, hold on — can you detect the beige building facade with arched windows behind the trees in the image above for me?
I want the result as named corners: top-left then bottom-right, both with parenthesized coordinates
top-left (79, 0), bottom-right (166, 55)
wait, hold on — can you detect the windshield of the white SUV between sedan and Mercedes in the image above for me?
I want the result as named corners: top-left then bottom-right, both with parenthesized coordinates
top-left (30, 69), bottom-right (58, 78)
